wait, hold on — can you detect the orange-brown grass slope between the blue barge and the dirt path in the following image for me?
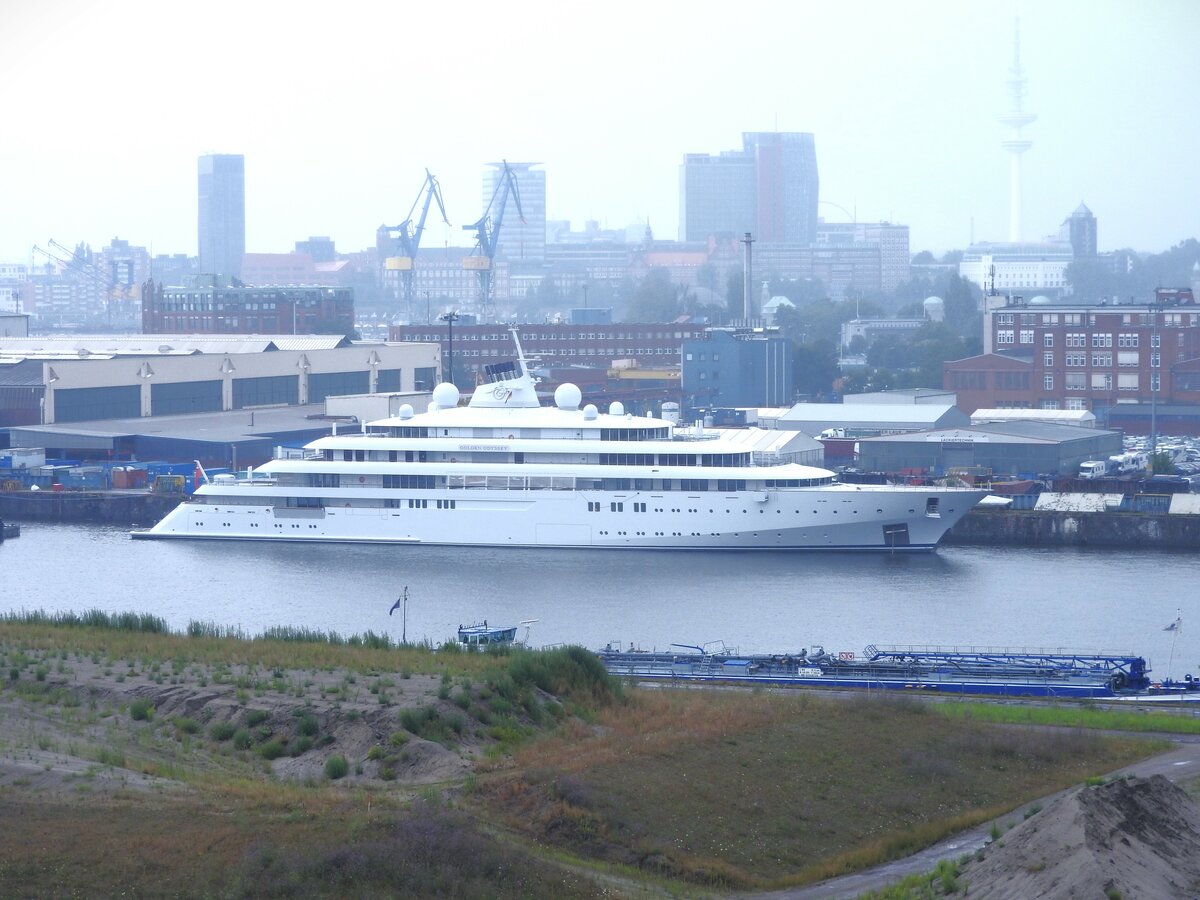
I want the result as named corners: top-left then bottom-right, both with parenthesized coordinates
top-left (484, 691), bottom-right (1161, 888)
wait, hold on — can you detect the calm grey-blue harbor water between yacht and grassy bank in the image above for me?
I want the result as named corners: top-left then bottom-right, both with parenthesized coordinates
top-left (0, 523), bottom-right (1200, 678)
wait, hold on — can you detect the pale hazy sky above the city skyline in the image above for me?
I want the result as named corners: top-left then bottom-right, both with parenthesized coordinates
top-left (0, 0), bottom-right (1200, 262)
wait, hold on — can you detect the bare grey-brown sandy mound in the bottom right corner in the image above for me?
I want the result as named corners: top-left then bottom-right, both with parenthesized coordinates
top-left (962, 775), bottom-right (1200, 900)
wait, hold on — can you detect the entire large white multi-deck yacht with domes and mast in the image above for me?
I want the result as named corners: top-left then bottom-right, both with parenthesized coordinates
top-left (132, 329), bottom-right (986, 552)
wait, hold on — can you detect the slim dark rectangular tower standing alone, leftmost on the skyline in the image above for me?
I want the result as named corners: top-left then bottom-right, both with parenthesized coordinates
top-left (199, 154), bottom-right (246, 277)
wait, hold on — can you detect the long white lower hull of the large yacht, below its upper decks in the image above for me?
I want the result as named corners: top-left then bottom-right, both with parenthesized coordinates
top-left (133, 485), bottom-right (985, 552)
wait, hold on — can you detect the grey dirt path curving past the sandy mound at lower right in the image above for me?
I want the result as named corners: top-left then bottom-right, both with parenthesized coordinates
top-left (739, 732), bottom-right (1200, 900)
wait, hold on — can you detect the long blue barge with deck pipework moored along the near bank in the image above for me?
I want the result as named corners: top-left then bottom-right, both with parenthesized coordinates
top-left (598, 642), bottom-right (1176, 700)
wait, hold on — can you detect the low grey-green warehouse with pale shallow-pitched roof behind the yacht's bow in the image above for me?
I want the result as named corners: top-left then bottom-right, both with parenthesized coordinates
top-left (858, 422), bottom-right (1122, 476)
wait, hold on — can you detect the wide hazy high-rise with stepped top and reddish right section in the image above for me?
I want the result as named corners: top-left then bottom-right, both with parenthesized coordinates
top-left (679, 132), bottom-right (820, 245)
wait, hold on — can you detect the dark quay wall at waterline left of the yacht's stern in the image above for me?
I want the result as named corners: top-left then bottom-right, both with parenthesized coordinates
top-left (0, 491), bottom-right (180, 527)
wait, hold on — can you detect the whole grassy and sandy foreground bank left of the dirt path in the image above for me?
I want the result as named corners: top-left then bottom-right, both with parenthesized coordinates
top-left (0, 616), bottom-right (1180, 898)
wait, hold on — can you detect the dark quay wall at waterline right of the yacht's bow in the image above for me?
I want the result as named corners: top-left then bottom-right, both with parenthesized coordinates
top-left (942, 509), bottom-right (1200, 550)
